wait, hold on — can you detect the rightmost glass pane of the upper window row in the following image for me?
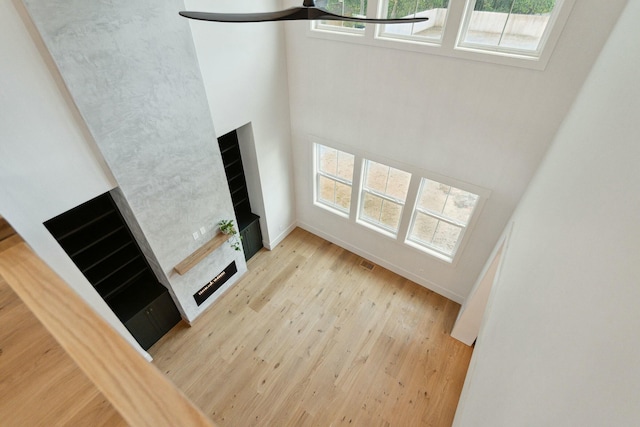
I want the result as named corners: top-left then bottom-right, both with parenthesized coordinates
top-left (462, 0), bottom-right (556, 52)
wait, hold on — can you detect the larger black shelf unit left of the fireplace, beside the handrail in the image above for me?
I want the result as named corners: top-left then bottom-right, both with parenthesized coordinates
top-left (44, 193), bottom-right (181, 349)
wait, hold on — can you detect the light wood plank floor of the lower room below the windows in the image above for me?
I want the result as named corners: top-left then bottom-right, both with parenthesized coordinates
top-left (150, 229), bottom-right (472, 427)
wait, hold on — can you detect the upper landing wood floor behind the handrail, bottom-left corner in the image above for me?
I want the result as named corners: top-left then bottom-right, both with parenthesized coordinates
top-left (0, 223), bottom-right (126, 427)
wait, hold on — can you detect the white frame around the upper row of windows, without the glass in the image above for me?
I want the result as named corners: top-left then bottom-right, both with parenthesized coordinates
top-left (307, 0), bottom-right (576, 70)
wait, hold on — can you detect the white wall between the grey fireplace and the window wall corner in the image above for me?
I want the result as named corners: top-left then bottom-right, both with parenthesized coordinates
top-left (185, 0), bottom-right (296, 247)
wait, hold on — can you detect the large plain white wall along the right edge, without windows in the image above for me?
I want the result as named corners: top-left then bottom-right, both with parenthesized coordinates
top-left (455, 1), bottom-right (640, 427)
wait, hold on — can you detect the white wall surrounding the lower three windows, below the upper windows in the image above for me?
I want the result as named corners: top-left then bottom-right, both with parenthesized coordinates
top-left (286, 0), bottom-right (625, 302)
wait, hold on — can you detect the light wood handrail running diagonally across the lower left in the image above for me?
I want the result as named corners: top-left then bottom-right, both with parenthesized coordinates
top-left (0, 243), bottom-right (214, 427)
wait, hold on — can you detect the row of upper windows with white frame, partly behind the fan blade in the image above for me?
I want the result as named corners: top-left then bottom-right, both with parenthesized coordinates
top-left (309, 0), bottom-right (575, 69)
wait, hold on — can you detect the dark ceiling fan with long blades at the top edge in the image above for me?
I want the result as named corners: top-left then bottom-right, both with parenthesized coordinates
top-left (180, 0), bottom-right (429, 24)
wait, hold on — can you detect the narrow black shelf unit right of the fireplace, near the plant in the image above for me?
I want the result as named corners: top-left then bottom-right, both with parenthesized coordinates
top-left (218, 130), bottom-right (262, 260)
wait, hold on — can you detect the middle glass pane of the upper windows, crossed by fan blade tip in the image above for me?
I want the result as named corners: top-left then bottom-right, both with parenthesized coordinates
top-left (381, 0), bottom-right (449, 42)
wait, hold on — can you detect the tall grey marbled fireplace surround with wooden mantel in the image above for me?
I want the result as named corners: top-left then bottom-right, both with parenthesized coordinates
top-left (23, 0), bottom-right (246, 322)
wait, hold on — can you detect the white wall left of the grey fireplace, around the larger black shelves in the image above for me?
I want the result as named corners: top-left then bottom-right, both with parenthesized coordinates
top-left (0, 0), bottom-right (146, 355)
